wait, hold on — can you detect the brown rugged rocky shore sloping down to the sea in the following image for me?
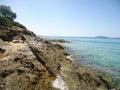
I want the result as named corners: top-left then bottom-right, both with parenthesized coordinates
top-left (0, 26), bottom-right (115, 90)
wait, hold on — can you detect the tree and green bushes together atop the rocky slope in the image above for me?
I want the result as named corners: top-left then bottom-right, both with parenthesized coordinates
top-left (0, 5), bottom-right (26, 29)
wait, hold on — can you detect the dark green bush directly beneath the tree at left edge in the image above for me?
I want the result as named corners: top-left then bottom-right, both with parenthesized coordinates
top-left (0, 16), bottom-right (13, 27)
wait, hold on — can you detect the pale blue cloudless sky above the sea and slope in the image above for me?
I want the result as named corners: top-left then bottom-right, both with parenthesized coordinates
top-left (0, 0), bottom-right (120, 37)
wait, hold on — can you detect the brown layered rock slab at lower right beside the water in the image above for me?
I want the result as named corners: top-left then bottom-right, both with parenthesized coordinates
top-left (77, 68), bottom-right (111, 90)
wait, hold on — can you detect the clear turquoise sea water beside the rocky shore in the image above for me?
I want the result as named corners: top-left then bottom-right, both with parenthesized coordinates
top-left (40, 37), bottom-right (120, 78)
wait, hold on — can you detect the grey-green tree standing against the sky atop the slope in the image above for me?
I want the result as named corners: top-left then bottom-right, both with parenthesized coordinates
top-left (0, 5), bottom-right (17, 20)
